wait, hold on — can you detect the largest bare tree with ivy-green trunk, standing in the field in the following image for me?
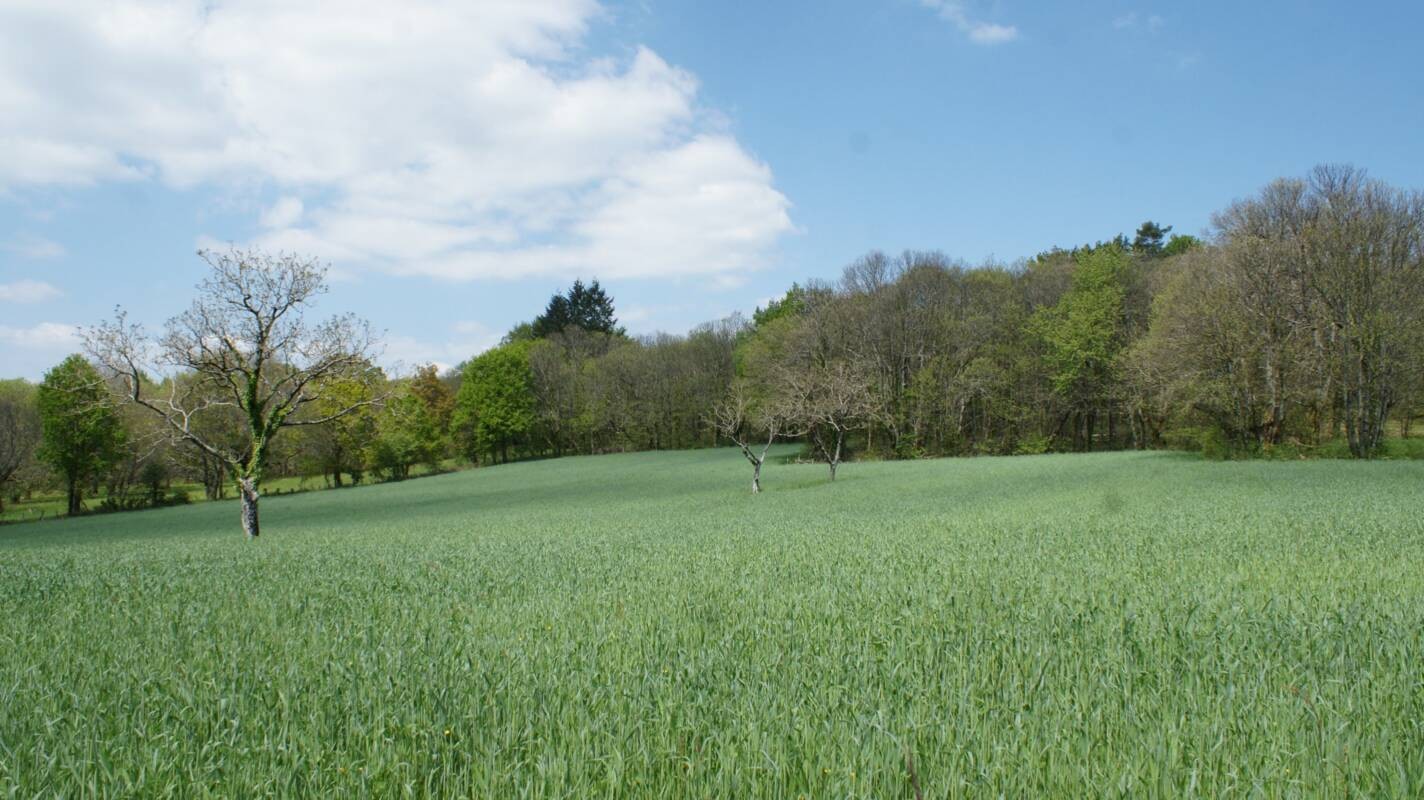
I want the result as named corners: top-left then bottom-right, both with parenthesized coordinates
top-left (85, 249), bottom-right (379, 538)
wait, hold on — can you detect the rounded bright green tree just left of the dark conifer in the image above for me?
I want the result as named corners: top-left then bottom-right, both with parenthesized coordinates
top-left (451, 343), bottom-right (535, 461)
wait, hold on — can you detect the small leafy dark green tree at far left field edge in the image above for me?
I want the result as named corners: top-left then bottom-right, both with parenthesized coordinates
top-left (36, 354), bottom-right (125, 514)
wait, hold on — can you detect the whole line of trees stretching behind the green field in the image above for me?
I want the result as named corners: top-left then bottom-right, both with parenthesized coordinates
top-left (0, 167), bottom-right (1424, 534)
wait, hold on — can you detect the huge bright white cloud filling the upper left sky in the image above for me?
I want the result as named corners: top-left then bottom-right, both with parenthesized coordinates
top-left (0, 0), bottom-right (791, 279)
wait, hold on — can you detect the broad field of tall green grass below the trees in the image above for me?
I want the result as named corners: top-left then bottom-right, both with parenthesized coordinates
top-left (0, 450), bottom-right (1424, 797)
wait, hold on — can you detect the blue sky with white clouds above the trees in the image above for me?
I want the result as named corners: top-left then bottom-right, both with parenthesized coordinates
top-left (0, 0), bottom-right (1424, 380)
